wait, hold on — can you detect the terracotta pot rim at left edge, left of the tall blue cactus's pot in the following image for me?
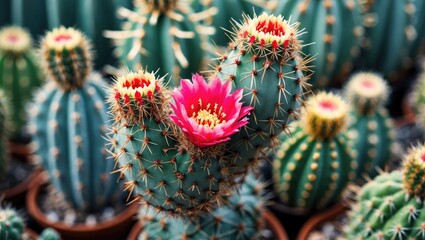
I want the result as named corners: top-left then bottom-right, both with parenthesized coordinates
top-left (0, 168), bottom-right (41, 202)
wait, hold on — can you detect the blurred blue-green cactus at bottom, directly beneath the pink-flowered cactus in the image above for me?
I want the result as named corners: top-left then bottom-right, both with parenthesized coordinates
top-left (139, 175), bottom-right (264, 240)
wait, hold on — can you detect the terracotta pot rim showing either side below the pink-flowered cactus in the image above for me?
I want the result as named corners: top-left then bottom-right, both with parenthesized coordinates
top-left (127, 211), bottom-right (289, 240)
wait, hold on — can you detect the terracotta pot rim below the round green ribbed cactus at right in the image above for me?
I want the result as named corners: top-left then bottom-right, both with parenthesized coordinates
top-left (297, 202), bottom-right (348, 240)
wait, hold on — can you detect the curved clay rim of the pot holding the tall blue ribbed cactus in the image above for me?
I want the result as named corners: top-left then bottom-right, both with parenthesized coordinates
top-left (26, 174), bottom-right (139, 232)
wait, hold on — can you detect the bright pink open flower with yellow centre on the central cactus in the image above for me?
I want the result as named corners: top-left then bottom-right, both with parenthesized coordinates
top-left (170, 74), bottom-right (252, 148)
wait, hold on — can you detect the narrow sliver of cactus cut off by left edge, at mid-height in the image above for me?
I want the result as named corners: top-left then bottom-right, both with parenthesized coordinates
top-left (0, 90), bottom-right (10, 180)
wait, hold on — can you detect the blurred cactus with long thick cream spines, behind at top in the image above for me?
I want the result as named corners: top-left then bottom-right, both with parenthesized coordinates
top-left (106, 0), bottom-right (212, 86)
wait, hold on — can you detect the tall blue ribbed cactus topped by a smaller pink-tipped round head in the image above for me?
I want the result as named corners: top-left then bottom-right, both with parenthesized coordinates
top-left (30, 27), bottom-right (119, 214)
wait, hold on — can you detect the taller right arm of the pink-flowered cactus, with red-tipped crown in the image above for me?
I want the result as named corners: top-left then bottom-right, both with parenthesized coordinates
top-left (213, 13), bottom-right (309, 174)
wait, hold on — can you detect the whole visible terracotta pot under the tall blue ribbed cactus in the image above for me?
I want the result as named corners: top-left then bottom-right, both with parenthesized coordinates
top-left (26, 174), bottom-right (139, 240)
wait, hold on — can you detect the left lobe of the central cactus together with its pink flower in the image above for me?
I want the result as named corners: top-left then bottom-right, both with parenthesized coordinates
top-left (109, 70), bottom-right (251, 216)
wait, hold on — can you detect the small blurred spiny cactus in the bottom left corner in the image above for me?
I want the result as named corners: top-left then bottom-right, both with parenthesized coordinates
top-left (0, 207), bottom-right (25, 240)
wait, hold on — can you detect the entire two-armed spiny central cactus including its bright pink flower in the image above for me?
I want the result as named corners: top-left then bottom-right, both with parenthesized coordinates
top-left (110, 14), bottom-right (306, 215)
